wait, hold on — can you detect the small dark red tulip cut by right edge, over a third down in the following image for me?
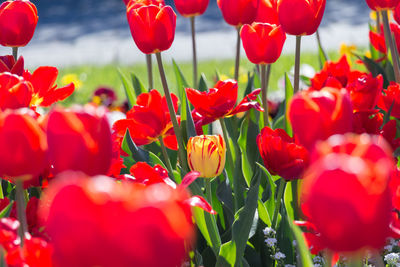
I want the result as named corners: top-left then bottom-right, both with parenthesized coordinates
top-left (378, 82), bottom-right (400, 119)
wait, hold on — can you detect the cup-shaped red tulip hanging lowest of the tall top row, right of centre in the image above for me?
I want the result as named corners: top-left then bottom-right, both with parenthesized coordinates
top-left (240, 22), bottom-right (286, 64)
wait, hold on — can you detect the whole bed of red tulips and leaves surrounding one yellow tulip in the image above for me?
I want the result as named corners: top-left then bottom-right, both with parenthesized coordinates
top-left (4, 0), bottom-right (400, 267)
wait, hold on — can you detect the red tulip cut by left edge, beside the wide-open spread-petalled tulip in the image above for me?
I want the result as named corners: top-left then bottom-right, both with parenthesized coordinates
top-left (0, 72), bottom-right (33, 110)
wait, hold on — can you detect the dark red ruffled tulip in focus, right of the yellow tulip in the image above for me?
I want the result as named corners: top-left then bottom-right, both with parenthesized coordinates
top-left (257, 127), bottom-right (308, 180)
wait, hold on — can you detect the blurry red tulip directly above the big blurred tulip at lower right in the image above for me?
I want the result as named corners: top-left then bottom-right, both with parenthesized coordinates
top-left (288, 87), bottom-right (353, 149)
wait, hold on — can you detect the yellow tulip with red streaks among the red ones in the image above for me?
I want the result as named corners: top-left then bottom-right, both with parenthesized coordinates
top-left (187, 135), bottom-right (226, 178)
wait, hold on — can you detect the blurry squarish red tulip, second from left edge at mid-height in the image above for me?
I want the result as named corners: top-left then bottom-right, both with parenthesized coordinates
top-left (46, 108), bottom-right (112, 178)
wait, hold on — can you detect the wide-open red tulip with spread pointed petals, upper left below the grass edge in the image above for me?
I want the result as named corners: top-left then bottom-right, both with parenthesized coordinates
top-left (24, 66), bottom-right (75, 107)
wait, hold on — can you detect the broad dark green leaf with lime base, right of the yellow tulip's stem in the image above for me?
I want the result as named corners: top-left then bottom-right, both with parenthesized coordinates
top-left (216, 169), bottom-right (260, 266)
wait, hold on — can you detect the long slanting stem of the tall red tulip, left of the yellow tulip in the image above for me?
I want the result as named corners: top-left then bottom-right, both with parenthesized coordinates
top-left (156, 53), bottom-right (189, 172)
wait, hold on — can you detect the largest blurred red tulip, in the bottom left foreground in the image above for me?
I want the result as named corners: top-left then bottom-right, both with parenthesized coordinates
top-left (40, 173), bottom-right (195, 267)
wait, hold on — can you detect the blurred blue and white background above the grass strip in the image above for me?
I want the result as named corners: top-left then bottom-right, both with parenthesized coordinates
top-left (1, 0), bottom-right (370, 67)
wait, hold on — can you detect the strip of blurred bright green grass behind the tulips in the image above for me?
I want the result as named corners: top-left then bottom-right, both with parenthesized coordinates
top-left (58, 52), bottom-right (338, 105)
